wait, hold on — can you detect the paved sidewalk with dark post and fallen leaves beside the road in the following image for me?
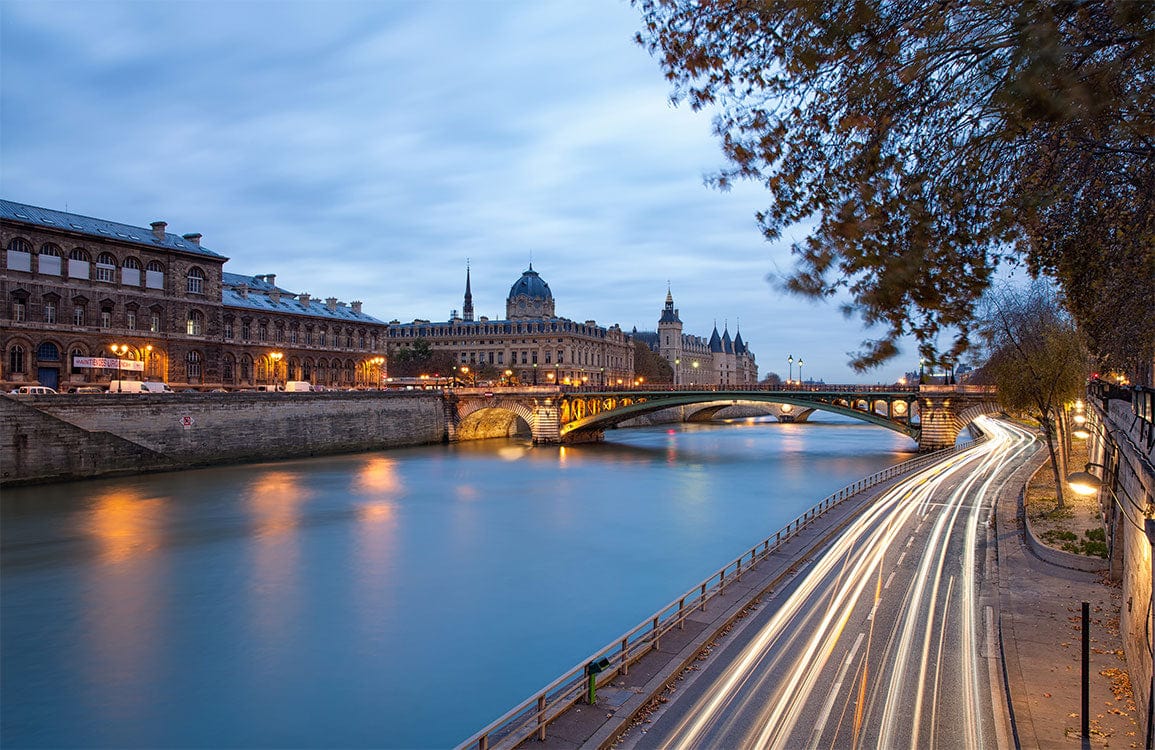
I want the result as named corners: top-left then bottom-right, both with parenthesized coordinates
top-left (996, 455), bottom-right (1143, 748)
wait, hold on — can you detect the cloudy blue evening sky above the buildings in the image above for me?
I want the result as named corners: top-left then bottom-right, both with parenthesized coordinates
top-left (0, 0), bottom-right (918, 384)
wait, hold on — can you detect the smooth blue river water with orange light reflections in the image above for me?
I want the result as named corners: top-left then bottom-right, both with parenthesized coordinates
top-left (0, 415), bottom-right (915, 748)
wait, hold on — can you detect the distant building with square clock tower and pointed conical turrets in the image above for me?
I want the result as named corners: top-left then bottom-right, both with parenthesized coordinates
top-left (634, 290), bottom-right (758, 386)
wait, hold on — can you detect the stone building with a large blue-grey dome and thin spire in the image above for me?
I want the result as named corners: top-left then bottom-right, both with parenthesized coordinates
top-left (388, 265), bottom-right (634, 387)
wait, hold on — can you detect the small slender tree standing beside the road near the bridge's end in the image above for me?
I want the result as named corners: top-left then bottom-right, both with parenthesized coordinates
top-left (979, 282), bottom-right (1087, 508)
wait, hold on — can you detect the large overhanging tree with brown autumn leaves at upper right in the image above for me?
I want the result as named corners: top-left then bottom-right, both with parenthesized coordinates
top-left (634, 0), bottom-right (1155, 370)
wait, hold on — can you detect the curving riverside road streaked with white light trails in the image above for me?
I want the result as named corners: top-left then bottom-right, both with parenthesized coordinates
top-left (619, 417), bottom-right (1040, 749)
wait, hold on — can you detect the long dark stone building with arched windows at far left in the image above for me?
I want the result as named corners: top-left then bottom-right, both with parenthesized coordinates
top-left (0, 200), bottom-right (387, 391)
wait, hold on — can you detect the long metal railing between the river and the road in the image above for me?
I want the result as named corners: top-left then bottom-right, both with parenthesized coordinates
top-left (457, 437), bottom-right (985, 750)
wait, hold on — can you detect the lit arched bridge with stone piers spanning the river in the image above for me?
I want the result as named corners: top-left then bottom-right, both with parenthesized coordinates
top-left (446, 385), bottom-right (1001, 451)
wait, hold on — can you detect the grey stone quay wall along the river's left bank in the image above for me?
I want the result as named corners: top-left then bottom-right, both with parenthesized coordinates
top-left (0, 392), bottom-right (447, 487)
